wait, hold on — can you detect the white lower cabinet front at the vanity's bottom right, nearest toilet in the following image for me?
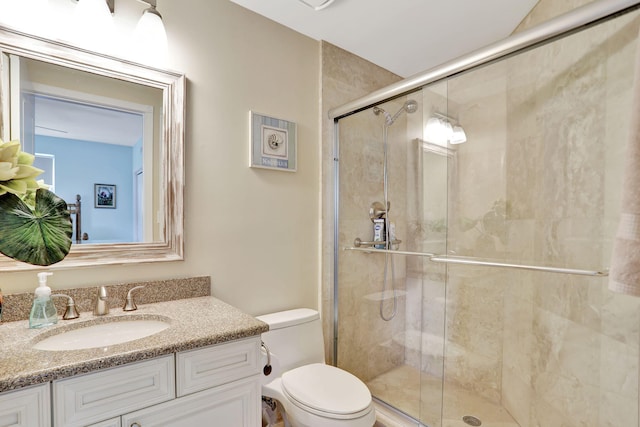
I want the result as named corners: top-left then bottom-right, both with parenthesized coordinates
top-left (122, 375), bottom-right (261, 427)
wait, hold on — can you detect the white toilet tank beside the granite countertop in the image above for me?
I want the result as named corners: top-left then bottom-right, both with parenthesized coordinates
top-left (257, 308), bottom-right (325, 372)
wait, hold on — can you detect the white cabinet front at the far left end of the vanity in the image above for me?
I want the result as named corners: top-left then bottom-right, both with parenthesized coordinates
top-left (0, 383), bottom-right (51, 427)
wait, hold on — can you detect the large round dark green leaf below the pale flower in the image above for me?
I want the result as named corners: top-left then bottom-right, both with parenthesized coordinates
top-left (0, 188), bottom-right (73, 266)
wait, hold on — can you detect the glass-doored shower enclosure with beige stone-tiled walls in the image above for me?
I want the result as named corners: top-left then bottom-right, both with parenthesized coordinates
top-left (331, 2), bottom-right (640, 427)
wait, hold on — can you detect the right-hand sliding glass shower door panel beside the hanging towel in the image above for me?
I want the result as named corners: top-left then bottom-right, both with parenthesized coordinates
top-left (440, 7), bottom-right (640, 427)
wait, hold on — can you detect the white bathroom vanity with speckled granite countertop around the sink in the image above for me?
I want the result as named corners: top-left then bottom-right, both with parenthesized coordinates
top-left (0, 297), bottom-right (268, 427)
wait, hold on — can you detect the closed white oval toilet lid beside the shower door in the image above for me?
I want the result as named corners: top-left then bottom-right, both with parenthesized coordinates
top-left (282, 363), bottom-right (371, 415)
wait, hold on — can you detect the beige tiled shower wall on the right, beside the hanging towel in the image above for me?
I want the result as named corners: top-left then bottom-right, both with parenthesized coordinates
top-left (502, 7), bottom-right (640, 427)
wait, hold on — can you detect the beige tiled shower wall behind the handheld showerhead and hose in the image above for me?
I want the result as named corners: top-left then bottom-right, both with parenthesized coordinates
top-left (338, 100), bottom-right (411, 381)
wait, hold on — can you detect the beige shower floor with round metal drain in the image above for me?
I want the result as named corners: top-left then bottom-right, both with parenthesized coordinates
top-left (367, 365), bottom-right (520, 427)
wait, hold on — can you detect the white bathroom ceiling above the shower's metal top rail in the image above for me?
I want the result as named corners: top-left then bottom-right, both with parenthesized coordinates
top-left (231, 0), bottom-right (538, 77)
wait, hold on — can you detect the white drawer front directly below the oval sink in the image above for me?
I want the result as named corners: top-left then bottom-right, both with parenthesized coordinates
top-left (53, 355), bottom-right (175, 427)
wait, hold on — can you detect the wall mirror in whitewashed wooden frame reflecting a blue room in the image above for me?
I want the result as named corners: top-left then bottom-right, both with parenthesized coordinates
top-left (0, 27), bottom-right (185, 271)
